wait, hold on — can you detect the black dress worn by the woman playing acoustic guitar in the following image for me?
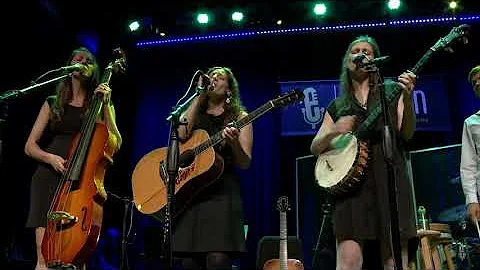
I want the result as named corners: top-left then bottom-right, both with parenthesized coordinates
top-left (173, 110), bottom-right (246, 257)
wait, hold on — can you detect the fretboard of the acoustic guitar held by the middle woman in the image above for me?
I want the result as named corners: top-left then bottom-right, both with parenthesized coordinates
top-left (192, 101), bottom-right (275, 155)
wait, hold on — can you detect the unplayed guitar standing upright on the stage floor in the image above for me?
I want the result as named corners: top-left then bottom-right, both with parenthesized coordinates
top-left (263, 196), bottom-right (304, 270)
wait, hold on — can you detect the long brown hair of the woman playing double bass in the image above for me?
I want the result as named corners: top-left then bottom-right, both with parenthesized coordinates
top-left (50, 47), bottom-right (100, 125)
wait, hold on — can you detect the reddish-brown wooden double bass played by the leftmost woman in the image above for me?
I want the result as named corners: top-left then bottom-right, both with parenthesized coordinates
top-left (42, 48), bottom-right (126, 268)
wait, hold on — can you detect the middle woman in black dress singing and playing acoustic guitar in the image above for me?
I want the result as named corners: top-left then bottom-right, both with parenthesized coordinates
top-left (173, 67), bottom-right (253, 269)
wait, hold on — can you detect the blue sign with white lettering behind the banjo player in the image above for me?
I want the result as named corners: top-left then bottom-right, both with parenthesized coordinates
top-left (279, 75), bottom-right (451, 136)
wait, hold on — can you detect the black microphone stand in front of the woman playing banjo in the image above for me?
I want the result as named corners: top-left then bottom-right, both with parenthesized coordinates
top-left (368, 65), bottom-right (402, 270)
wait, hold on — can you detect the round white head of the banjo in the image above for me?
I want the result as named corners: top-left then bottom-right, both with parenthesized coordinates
top-left (315, 132), bottom-right (359, 189)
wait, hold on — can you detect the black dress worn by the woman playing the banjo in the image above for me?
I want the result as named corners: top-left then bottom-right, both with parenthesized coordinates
top-left (327, 81), bottom-right (416, 259)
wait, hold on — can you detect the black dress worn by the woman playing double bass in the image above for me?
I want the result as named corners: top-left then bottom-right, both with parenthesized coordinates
top-left (26, 96), bottom-right (83, 228)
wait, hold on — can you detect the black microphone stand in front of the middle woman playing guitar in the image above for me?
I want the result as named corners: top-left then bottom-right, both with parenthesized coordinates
top-left (163, 84), bottom-right (204, 269)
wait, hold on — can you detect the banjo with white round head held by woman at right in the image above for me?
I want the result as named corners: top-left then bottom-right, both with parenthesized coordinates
top-left (314, 24), bottom-right (470, 195)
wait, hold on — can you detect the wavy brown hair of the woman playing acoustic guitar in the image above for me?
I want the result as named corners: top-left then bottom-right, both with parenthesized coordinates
top-left (201, 67), bottom-right (246, 124)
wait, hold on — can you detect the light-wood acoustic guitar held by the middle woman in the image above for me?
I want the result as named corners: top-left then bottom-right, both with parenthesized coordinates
top-left (132, 89), bottom-right (304, 221)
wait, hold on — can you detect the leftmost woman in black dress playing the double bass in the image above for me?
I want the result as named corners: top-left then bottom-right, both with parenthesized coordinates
top-left (25, 47), bottom-right (122, 270)
